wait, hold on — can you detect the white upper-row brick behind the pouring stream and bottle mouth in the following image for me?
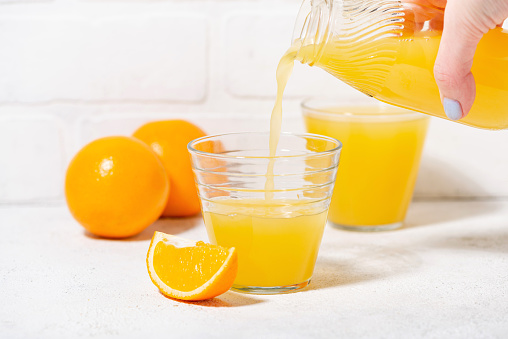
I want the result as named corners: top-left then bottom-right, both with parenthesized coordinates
top-left (224, 11), bottom-right (363, 98)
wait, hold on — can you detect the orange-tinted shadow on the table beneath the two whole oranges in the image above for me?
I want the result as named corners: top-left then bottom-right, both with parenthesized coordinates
top-left (85, 214), bottom-right (202, 241)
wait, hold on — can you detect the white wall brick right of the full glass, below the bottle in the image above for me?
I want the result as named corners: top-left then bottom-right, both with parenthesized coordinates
top-left (415, 118), bottom-right (508, 198)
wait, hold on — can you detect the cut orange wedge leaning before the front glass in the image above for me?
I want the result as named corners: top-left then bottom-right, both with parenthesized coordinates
top-left (146, 232), bottom-right (238, 300)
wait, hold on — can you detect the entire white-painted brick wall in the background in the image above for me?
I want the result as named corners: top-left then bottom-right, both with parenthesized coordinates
top-left (0, 0), bottom-right (508, 204)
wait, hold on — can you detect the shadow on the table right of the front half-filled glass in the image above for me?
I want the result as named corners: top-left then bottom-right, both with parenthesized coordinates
top-left (306, 245), bottom-right (421, 291)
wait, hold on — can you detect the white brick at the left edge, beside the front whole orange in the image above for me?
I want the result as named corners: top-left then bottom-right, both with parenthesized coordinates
top-left (0, 115), bottom-right (65, 203)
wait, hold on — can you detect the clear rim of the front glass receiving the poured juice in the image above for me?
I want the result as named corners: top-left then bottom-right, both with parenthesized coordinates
top-left (187, 132), bottom-right (343, 159)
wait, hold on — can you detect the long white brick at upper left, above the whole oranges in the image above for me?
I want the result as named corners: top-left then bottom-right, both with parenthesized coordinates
top-left (0, 10), bottom-right (208, 103)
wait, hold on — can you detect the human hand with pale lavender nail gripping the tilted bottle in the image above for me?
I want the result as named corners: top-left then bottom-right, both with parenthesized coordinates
top-left (426, 0), bottom-right (508, 120)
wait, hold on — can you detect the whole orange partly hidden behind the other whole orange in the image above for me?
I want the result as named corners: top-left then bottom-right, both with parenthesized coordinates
top-left (133, 120), bottom-right (206, 217)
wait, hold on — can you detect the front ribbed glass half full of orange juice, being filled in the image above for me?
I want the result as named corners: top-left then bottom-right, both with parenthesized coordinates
top-left (188, 132), bottom-right (341, 294)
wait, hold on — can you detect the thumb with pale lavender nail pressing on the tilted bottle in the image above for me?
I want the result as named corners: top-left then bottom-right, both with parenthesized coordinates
top-left (434, 0), bottom-right (483, 120)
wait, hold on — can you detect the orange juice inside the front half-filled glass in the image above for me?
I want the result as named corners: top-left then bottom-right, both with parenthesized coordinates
top-left (203, 198), bottom-right (327, 290)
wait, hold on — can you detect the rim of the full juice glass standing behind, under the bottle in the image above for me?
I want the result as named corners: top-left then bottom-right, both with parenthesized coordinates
top-left (300, 97), bottom-right (430, 120)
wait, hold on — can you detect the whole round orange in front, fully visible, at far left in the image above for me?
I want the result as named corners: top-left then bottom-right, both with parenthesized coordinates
top-left (65, 137), bottom-right (169, 238)
